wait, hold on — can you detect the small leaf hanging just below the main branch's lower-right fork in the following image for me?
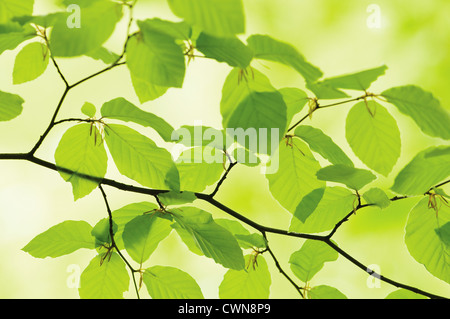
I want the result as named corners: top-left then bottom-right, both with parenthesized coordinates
top-left (289, 240), bottom-right (339, 283)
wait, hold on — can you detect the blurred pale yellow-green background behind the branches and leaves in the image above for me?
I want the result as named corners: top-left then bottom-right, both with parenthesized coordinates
top-left (0, 0), bottom-right (450, 298)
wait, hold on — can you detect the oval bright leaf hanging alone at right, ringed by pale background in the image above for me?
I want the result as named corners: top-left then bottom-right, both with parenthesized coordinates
top-left (345, 101), bottom-right (401, 176)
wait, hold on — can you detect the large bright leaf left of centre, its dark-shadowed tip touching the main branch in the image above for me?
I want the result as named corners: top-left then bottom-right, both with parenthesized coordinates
top-left (105, 124), bottom-right (179, 190)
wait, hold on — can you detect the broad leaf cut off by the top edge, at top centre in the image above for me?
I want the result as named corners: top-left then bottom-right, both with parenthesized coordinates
top-left (168, 0), bottom-right (245, 37)
